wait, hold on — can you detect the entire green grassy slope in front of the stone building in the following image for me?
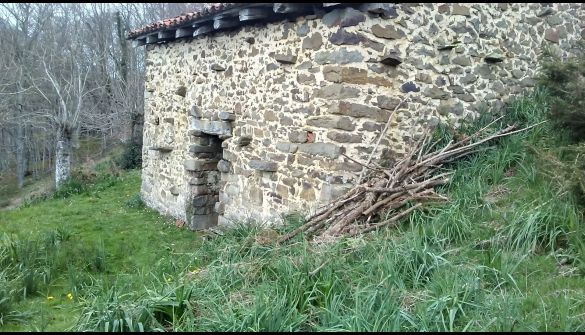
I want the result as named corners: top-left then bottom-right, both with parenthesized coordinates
top-left (0, 90), bottom-right (585, 331)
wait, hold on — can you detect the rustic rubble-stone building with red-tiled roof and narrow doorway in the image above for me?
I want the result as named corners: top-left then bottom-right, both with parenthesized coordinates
top-left (128, 3), bottom-right (585, 229)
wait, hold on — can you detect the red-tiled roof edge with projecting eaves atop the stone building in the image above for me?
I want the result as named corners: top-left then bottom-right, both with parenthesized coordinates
top-left (127, 3), bottom-right (393, 46)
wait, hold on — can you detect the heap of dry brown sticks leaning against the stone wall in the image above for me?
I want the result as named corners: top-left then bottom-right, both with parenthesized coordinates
top-left (278, 117), bottom-right (542, 243)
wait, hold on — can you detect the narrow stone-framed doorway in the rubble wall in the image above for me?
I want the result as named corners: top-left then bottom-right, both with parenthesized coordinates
top-left (185, 131), bottom-right (223, 230)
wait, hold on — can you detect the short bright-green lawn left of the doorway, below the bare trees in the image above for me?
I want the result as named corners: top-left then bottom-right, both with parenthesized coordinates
top-left (0, 170), bottom-right (198, 331)
